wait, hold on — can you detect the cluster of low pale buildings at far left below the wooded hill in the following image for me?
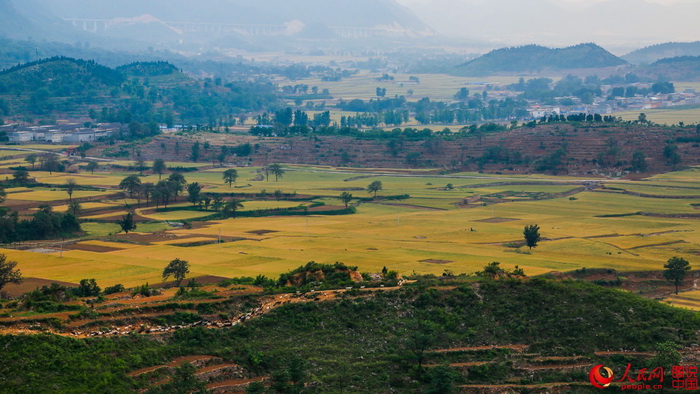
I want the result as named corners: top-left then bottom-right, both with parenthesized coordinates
top-left (0, 123), bottom-right (122, 144)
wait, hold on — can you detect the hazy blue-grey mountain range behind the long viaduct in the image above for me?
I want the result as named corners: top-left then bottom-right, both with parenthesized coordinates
top-left (5, 0), bottom-right (434, 47)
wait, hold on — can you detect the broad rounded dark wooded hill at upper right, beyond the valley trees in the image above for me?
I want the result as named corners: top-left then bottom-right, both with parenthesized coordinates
top-left (453, 44), bottom-right (626, 76)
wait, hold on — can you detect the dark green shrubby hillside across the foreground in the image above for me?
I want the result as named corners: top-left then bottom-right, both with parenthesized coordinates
top-left (0, 279), bottom-right (700, 392)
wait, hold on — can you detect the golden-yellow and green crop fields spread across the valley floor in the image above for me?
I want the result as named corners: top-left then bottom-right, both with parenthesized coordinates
top-left (2, 151), bottom-right (700, 308)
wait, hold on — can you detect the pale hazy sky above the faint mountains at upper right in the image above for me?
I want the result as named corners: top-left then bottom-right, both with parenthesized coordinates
top-left (396, 0), bottom-right (700, 52)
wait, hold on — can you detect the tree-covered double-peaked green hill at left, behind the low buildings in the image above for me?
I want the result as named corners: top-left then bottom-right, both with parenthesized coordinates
top-left (0, 57), bottom-right (278, 125)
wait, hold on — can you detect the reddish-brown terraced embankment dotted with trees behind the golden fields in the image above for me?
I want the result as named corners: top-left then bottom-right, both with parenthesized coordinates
top-left (124, 124), bottom-right (700, 175)
